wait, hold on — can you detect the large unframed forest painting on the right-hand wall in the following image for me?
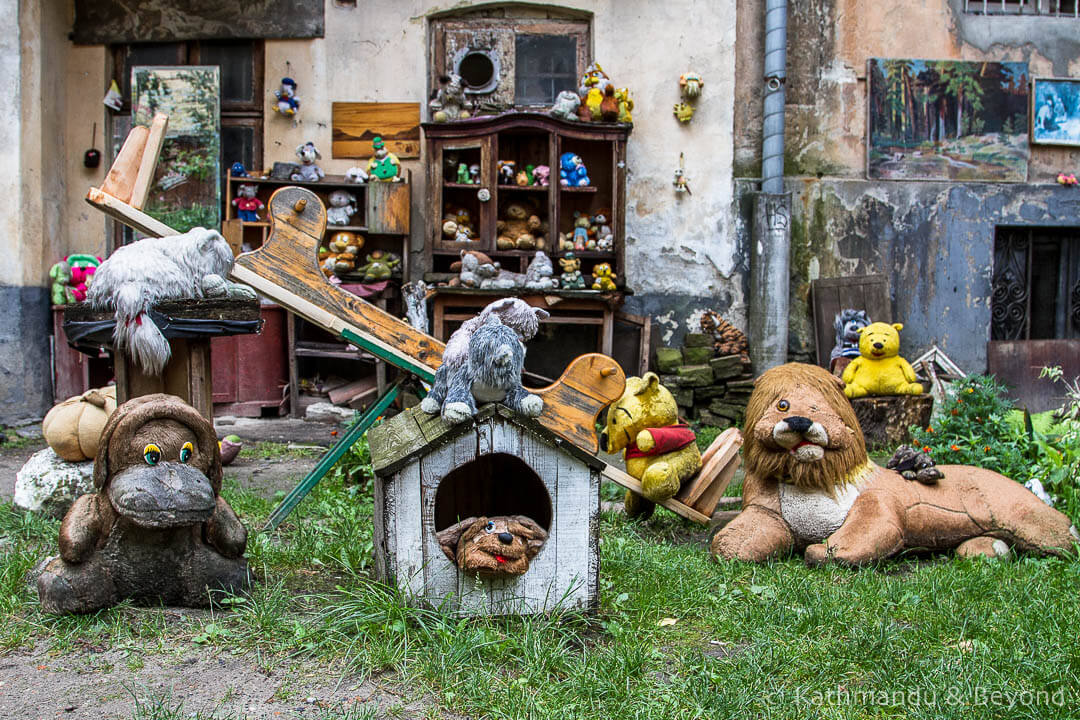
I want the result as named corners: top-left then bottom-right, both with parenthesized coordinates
top-left (866, 58), bottom-right (1029, 182)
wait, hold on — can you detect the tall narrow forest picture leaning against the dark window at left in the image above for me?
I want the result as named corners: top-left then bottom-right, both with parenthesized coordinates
top-left (132, 65), bottom-right (221, 232)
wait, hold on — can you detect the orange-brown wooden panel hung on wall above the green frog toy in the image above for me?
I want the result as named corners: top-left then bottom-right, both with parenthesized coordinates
top-left (330, 103), bottom-right (420, 159)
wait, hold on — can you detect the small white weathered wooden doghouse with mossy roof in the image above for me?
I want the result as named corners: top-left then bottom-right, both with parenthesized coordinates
top-left (368, 405), bottom-right (603, 615)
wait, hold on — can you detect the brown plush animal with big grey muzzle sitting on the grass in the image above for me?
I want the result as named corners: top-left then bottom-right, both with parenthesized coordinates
top-left (38, 394), bottom-right (251, 614)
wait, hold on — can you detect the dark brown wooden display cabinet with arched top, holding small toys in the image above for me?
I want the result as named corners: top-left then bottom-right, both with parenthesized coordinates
top-left (423, 112), bottom-right (632, 280)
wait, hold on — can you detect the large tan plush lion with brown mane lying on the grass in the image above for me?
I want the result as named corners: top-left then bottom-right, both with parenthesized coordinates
top-left (712, 363), bottom-right (1080, 567)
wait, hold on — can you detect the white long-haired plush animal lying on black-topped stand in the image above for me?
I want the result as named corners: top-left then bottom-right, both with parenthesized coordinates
top-left (86, 228), bottom-right (255, 375)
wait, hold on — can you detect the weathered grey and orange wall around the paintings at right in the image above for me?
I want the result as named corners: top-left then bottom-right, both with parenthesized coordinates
top-left (734, 0), bottom-right (1080, 371)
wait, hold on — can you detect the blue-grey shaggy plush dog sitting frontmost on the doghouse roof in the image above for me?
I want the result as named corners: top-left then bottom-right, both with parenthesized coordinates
top-left (420, 313), bottom-right (543, 423)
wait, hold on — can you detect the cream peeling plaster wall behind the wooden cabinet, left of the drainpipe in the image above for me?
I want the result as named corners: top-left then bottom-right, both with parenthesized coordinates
top-left (264, 0), bottom-right (745, 342)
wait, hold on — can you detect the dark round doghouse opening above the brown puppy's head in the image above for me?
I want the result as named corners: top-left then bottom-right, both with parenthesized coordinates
top-left (435, 452), bottom-right (551, 531)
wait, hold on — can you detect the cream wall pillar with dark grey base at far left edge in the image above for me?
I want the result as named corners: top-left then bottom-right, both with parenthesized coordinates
top-left (0, 0), bottom-right (70, 424)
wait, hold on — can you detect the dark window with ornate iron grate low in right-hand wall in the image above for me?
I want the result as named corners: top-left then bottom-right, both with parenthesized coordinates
top-left (990, 227), bottom-right (1080, 340)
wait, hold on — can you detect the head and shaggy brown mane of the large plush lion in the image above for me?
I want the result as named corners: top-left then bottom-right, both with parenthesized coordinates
top-left (744, 363), bottom-right (867, 492)
